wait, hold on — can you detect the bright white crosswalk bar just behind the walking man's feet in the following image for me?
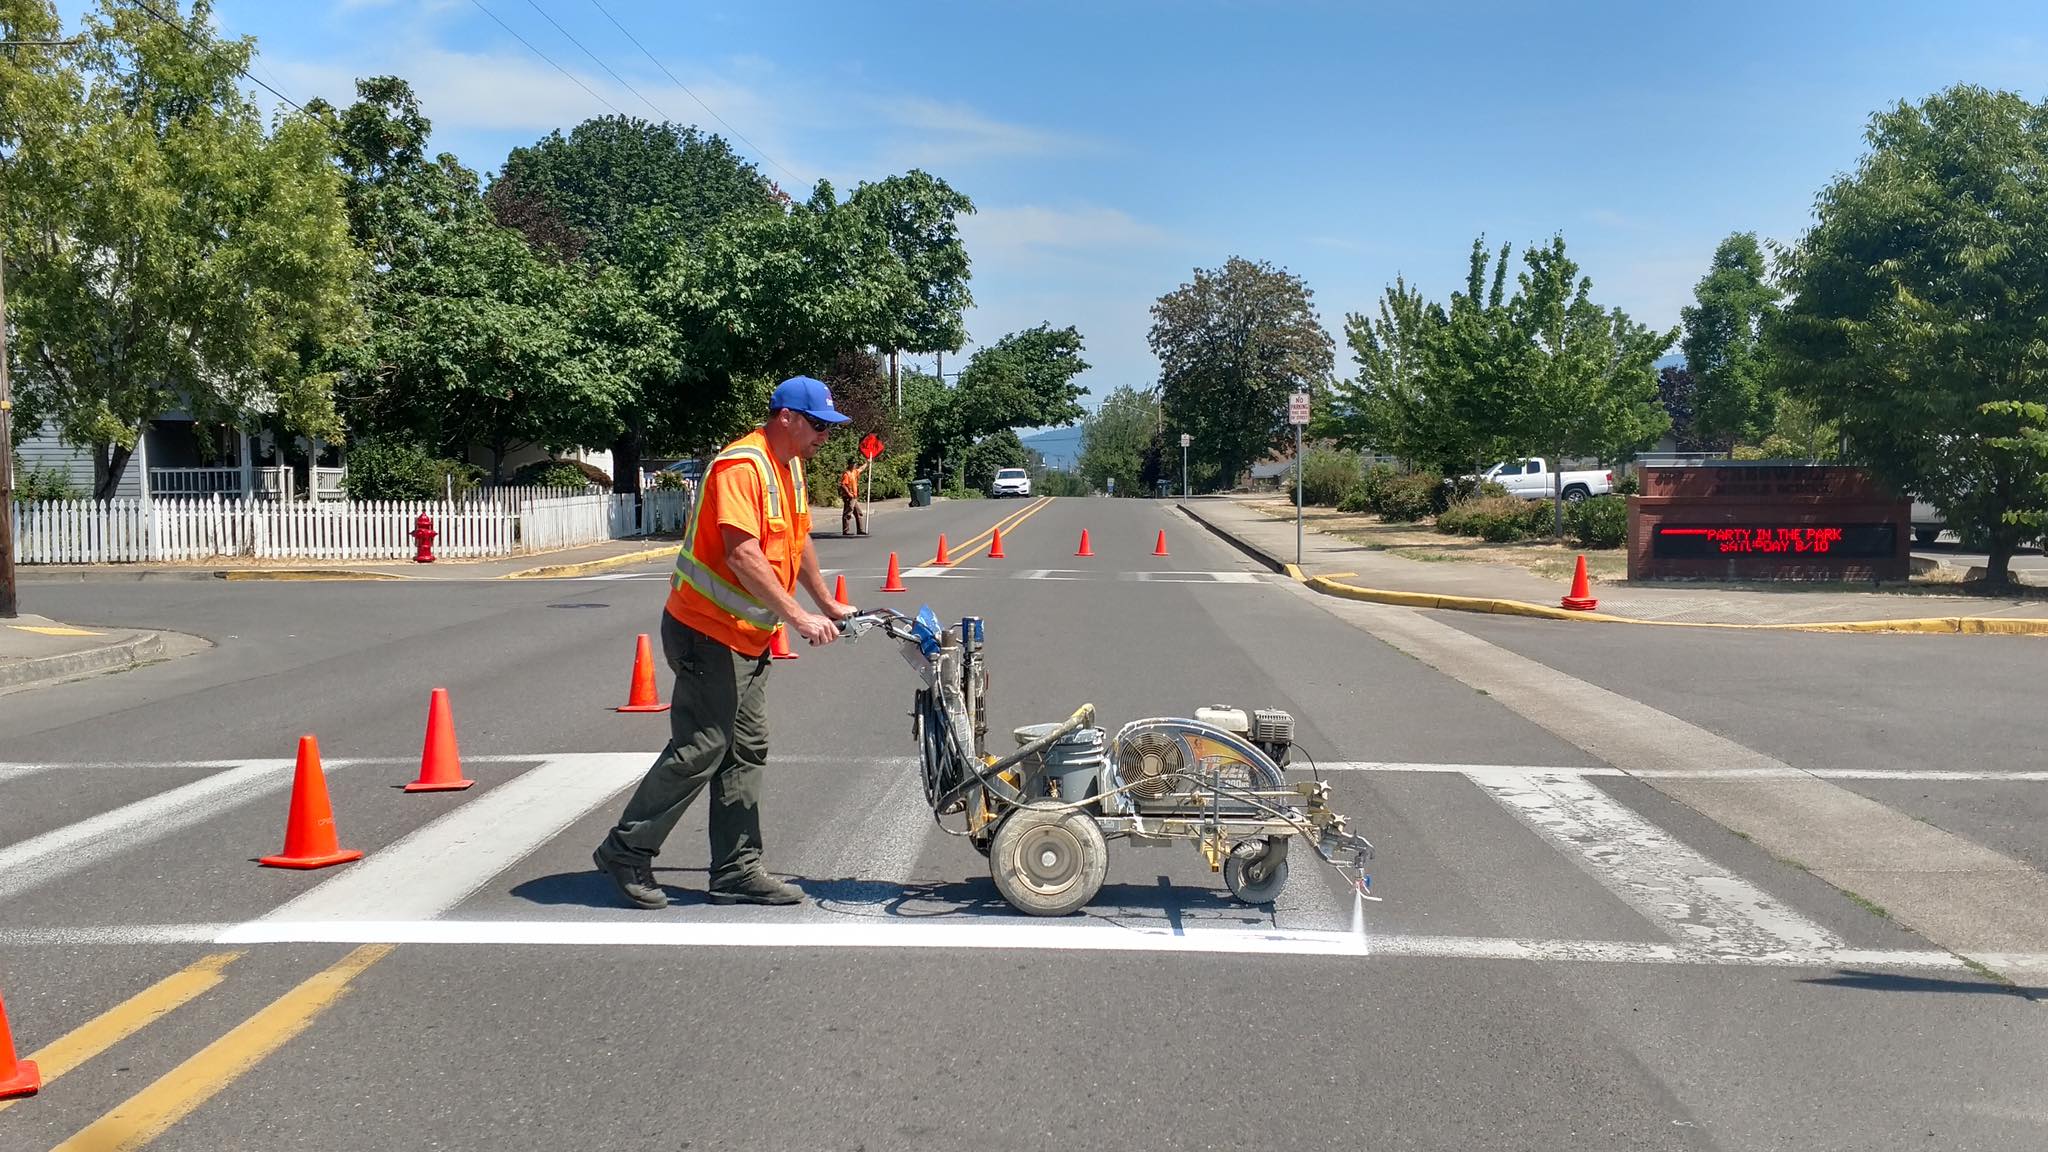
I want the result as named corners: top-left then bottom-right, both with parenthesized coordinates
top-left (251, 752), bottom-right (649, 920)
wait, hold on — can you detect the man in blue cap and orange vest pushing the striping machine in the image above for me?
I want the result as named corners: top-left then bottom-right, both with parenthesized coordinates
top-left (592, 375), bottom-right (854, 908)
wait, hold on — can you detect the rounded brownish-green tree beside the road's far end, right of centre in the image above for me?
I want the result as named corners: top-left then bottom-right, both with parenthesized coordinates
top-left (1155, 256), bottom-right (1333, 484)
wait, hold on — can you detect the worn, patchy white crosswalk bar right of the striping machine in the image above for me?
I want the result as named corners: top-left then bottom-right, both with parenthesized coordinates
top-left (1470, 773), bottom-right (1841, 957)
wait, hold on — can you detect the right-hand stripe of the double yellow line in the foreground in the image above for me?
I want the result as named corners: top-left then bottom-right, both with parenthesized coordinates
top-left (53, 945), bottom-right (393, 1152)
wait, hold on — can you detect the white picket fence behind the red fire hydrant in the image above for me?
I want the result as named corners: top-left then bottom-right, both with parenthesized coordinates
top-left (14, 488), bottom-right (690, 564)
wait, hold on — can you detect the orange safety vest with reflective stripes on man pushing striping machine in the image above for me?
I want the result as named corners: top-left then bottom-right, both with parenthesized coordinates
top-left (668, 428), bottom-right (811, 656)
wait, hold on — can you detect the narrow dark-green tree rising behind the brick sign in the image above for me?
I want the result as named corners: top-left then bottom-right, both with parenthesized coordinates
top-left (1679, 232), bottom-right (1784, 449)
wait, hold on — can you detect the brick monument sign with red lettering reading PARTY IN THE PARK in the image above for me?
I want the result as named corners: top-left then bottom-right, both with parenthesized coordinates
top-left (1628, 463), bottom-right (1913, 580)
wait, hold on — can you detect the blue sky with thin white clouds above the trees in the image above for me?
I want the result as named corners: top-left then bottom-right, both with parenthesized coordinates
top-left (61, 0), bottom-right (2048, 412)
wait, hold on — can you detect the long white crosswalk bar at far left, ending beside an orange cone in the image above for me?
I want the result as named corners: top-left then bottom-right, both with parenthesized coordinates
top-left (0, 760), bottom-right (293, 900)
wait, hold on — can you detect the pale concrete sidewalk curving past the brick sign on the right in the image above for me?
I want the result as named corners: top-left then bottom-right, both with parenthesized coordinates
top-left (1180, 487), bottom-right (2048, 631)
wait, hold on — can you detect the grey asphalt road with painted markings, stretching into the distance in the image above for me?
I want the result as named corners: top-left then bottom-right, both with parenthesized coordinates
top-left (0, 500), bottom-right (2048, 1152)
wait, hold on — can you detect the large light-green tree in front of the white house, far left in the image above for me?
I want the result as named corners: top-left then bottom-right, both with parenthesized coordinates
top-left (0, 0), bottom-right (362, 498)
